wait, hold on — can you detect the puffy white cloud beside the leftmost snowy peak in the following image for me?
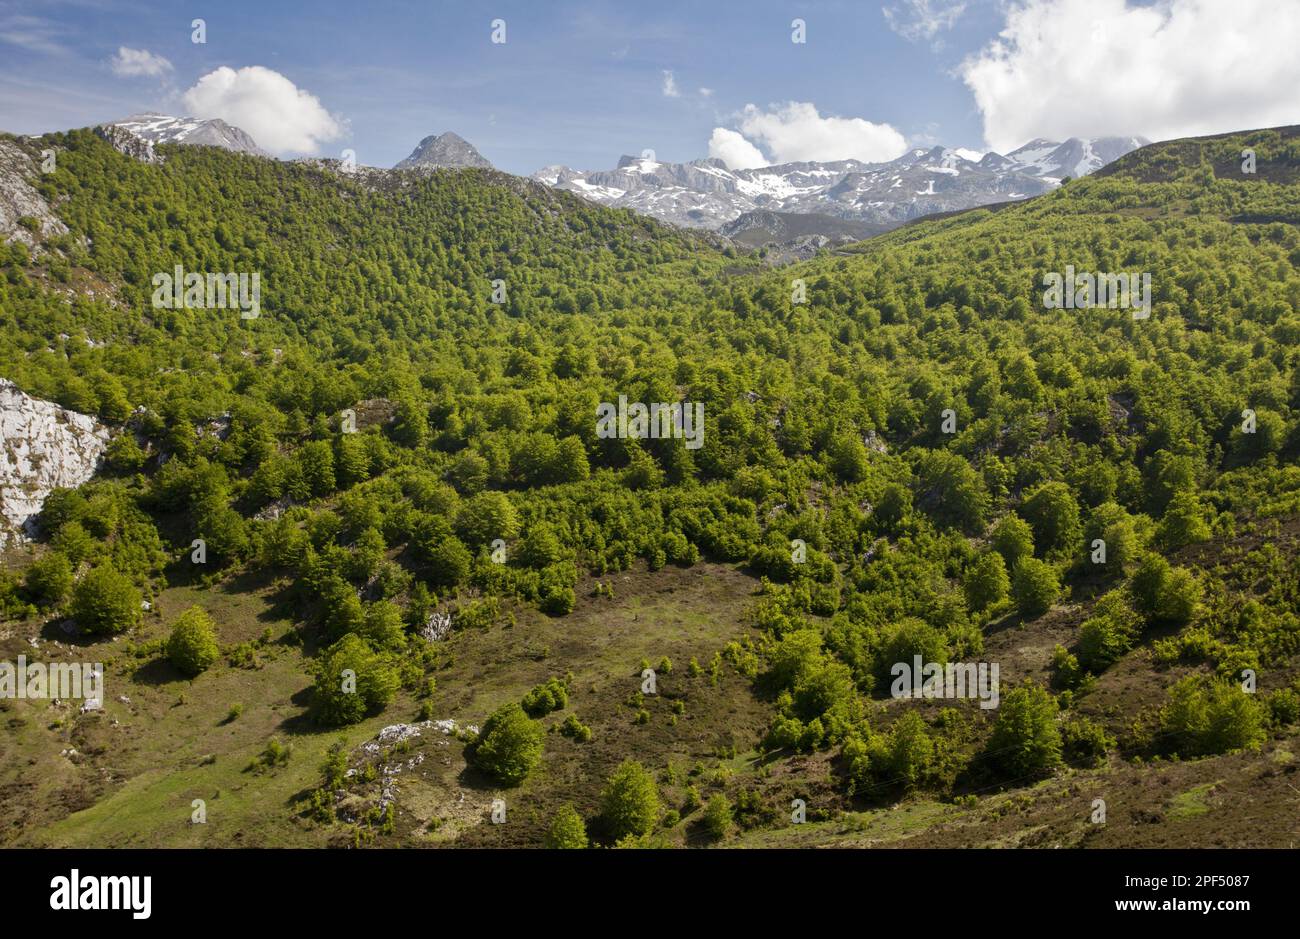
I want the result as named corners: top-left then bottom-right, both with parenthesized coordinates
top-left (182, 65), bottom-right (345, 153)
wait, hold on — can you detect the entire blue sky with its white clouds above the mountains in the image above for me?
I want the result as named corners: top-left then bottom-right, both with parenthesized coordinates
top-left (0, 0), bottom-right (1300, 174)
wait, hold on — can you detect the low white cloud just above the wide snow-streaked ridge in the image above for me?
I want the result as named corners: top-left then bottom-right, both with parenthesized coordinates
top-left (709, 101), bottom-right (907, 165)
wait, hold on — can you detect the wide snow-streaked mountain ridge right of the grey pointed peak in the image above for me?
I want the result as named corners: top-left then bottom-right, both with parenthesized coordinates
top-left (533, 137), bottom-right (1148, 235)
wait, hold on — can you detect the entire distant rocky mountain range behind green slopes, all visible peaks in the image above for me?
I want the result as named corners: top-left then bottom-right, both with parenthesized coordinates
top-left (96, 113), bottom-right (1149, 247)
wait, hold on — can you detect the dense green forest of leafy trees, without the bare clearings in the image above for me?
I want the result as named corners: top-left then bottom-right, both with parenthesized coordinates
top-left (0, 124), bottom-right (1300, 847)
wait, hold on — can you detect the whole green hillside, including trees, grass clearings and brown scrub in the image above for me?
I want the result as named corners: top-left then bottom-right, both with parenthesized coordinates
top-left (0, 129), bottom-right (1300, 847)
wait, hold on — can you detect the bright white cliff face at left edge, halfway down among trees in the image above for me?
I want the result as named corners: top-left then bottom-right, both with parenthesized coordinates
top-left (0, 378), bottom-right (109, 549)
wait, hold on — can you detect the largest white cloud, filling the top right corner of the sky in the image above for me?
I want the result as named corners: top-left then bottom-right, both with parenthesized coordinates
top-left (959, 0), bottom-right (1300, 153)
